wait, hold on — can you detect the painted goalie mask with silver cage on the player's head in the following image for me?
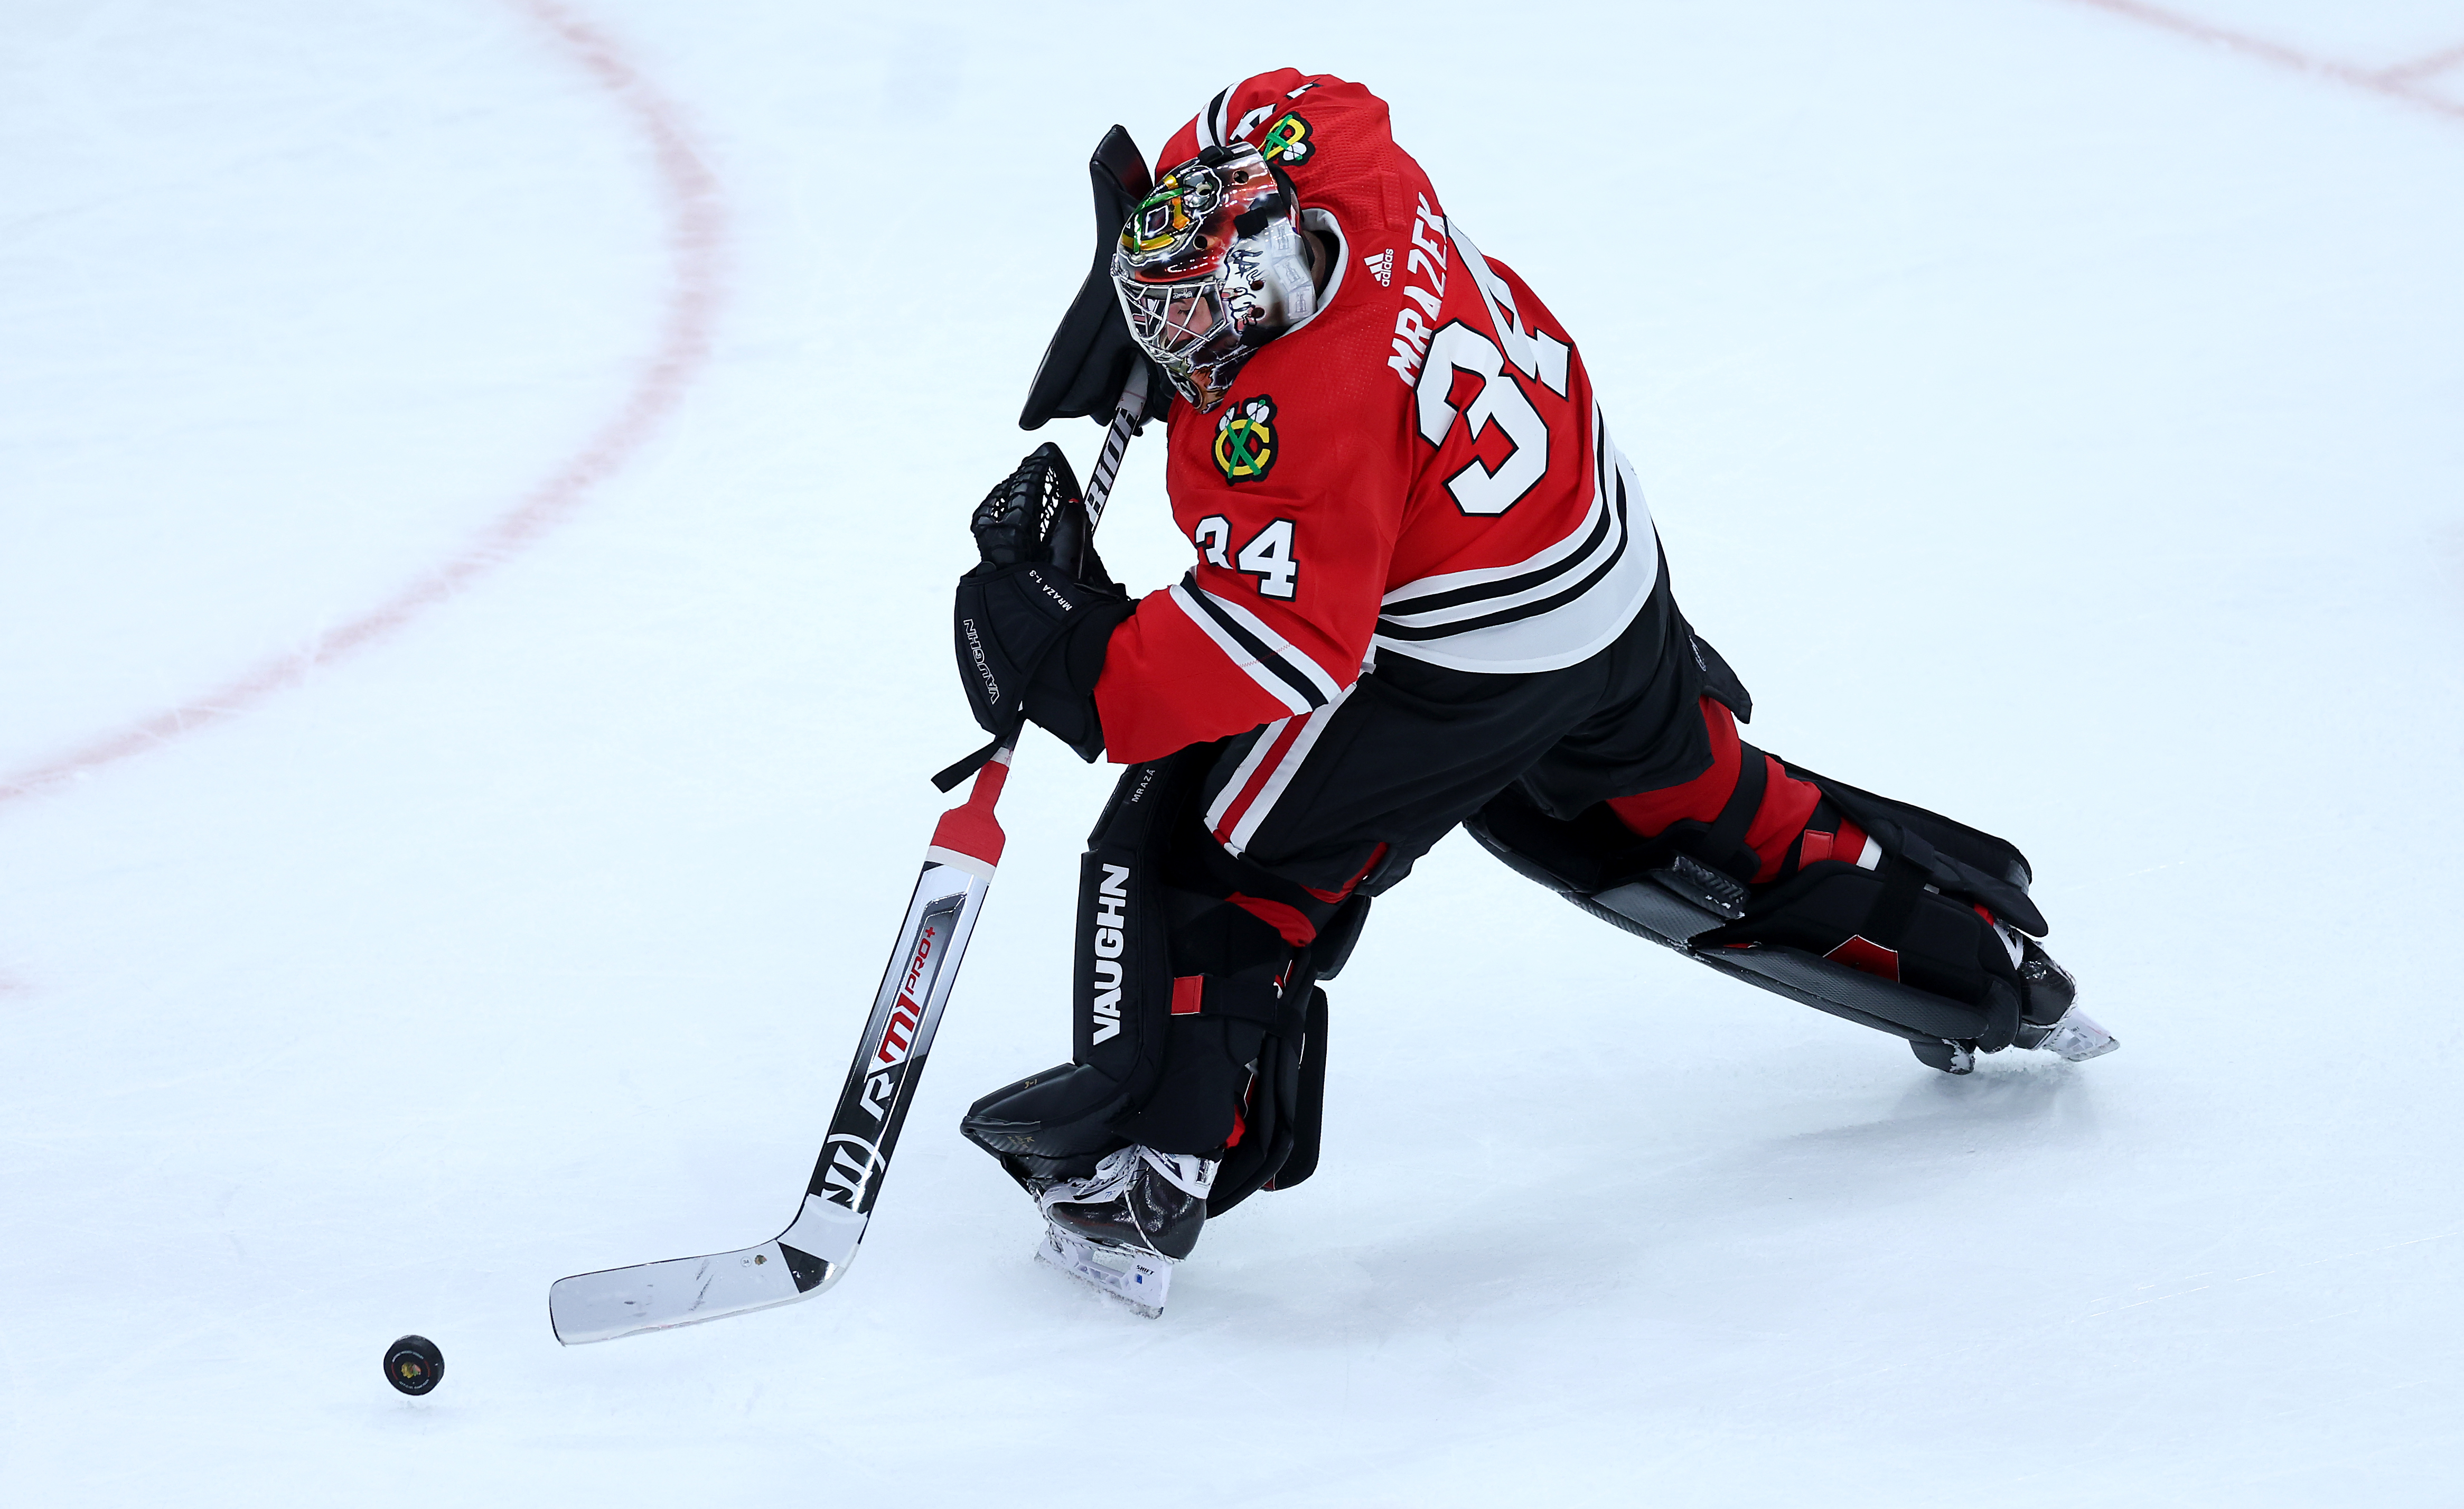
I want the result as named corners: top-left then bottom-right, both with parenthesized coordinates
top-left (1111, 141), bottom-right (1318, 414)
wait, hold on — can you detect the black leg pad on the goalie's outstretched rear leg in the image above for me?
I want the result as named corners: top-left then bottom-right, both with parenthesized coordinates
top-left (1466, 750), bottom-right (2070, 1073)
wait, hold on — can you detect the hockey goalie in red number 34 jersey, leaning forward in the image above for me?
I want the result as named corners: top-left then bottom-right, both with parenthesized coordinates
top-left (956, 69), bottom-right (2114, 1312)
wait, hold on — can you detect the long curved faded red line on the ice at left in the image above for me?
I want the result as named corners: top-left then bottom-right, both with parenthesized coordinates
top-left (0, 0), bottom-right (725, 804)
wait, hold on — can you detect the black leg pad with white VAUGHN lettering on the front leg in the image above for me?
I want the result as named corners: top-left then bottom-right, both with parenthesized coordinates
top-left (961, 744), bottom-right (1367, 1213)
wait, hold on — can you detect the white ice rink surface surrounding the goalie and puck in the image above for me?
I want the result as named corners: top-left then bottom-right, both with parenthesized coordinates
top-left (0, 0), bottom-right (2464, 1509)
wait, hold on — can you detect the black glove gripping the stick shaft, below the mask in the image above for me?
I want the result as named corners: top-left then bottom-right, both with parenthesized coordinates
top-left (953, 441), bottom-right (1136, 759)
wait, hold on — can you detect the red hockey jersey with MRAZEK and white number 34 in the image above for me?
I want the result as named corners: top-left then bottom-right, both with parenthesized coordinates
top-left (1094, 69), bottom-right (1659, 765)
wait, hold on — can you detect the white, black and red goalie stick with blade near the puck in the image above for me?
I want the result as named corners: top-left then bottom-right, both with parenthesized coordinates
top-left (547, 365), bottom-right (1146, 1346)
